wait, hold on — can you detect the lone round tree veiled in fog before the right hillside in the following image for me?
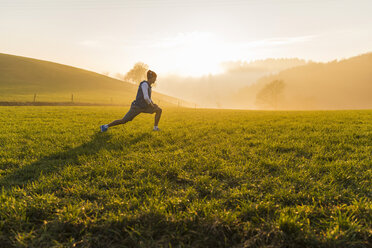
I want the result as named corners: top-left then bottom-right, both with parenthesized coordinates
top-left (256, 80), bottom-right (285, 109)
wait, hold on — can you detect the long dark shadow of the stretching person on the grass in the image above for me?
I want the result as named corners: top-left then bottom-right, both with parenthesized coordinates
top-left (0, 133), bottom-right (147, 189)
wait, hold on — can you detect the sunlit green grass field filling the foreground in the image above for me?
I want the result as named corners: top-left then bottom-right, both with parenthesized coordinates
top-left (0, 107), bottom-right (372, 247)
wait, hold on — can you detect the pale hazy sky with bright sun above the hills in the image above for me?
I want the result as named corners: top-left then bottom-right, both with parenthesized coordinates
top-left (0, 0), bottom-right (372, 75)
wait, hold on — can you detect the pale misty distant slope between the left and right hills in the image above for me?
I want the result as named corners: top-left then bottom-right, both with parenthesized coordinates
top-left (156, 59), bottom-right (306, 108)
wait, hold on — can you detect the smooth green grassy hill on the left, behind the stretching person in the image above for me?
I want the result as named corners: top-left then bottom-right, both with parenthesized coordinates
top-left (0, 54), bottom-right (178, 105)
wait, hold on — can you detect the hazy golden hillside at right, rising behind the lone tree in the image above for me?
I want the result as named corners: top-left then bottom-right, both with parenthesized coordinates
top-left (235, 53), bottom-right (372, 109)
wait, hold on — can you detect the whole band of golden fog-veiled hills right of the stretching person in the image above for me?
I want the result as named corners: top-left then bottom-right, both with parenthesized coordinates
top-left (156, 53), bottom-right (372, 109)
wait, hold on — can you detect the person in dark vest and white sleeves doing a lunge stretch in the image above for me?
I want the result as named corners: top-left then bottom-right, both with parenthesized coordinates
top-left (101, 70), bottom-right (162, 132)
